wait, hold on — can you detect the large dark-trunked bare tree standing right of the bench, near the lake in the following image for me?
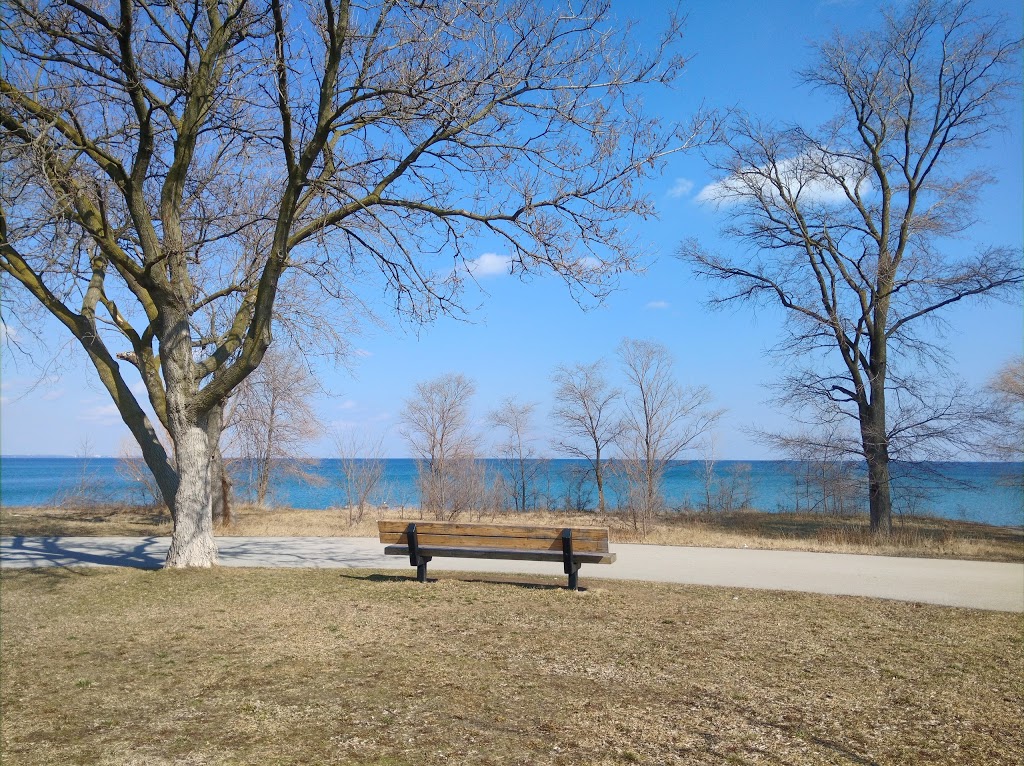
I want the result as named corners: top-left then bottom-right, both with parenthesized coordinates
top-left (682, 0), bottom-right (1024, 535)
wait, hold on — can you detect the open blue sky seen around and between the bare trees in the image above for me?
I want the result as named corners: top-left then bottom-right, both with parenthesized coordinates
top-left (0, 0), bottom-right (1024, 459)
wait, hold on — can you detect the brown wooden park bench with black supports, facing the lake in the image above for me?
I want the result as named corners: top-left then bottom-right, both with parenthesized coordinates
top-left (377, 521), bottom-right (615, 591)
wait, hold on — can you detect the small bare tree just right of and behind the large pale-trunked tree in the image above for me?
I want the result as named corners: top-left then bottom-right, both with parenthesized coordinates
top-left (227, 348), bottom-right (323, 506)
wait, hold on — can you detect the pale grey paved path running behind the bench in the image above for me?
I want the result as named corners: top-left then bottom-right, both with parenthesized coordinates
top-left (0, 537), bottom-right (1024, 611)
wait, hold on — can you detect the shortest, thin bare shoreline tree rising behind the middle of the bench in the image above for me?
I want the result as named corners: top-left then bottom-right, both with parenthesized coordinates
top-left (487, 396), bottom-right (547, 511)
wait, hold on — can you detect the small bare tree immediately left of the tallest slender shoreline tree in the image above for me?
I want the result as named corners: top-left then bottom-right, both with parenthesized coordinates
top-left (551, 360), bottom-right (622, 513)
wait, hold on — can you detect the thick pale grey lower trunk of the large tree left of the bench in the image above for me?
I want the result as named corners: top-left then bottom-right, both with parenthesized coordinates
top-left (165, 424), bottom-right (217, 567)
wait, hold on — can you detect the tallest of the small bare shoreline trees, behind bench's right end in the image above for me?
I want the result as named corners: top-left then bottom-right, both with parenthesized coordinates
top-left (616, 338), bottom-right (721, 534)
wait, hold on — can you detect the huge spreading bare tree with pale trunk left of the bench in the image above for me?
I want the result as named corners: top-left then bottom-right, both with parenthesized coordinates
top-left (0, 0), bottom-right (700, 566)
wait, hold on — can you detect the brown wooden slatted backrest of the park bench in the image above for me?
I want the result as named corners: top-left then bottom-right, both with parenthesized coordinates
top-left (377, 521), bottom-right (608, 553)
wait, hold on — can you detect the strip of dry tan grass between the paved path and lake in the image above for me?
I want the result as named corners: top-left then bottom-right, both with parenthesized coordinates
top-left (0, 507), bottom-right (1024, 561)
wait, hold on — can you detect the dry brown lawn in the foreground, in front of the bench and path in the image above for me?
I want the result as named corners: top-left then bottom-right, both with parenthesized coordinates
top-left (0, 568), bottom-right (1024, 766)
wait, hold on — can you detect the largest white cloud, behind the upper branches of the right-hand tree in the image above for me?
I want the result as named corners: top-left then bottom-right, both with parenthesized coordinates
top-left (694, 151), bottom-right (871, 207)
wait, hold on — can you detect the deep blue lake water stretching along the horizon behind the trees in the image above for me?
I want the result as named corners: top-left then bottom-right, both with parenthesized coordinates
top-left (0, 457), bottom-right (1024, 526)
